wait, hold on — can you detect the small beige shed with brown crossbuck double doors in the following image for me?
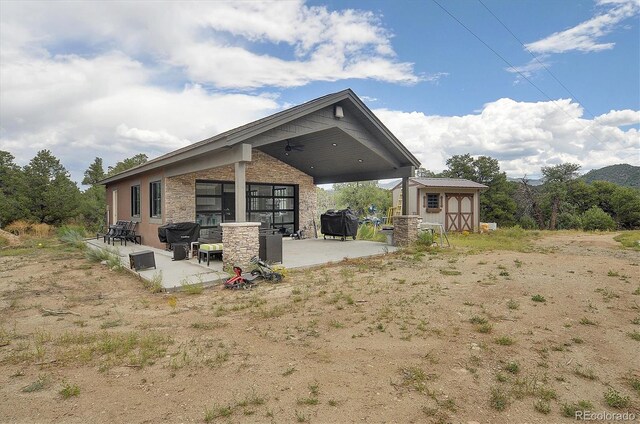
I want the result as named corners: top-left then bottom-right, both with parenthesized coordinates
top-left (392, 178), bottom-right (488, 232)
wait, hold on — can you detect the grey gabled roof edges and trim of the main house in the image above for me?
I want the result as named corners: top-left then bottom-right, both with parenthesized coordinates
top-left (101, 89), bottom-right (420, 184)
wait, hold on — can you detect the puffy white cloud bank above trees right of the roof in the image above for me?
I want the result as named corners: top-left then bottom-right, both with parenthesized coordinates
top-left (374, 99), bottom-right (640, 176)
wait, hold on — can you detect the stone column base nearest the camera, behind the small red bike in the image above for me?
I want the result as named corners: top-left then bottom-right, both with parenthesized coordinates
top-left (220, 222), bottom-right (260, 269)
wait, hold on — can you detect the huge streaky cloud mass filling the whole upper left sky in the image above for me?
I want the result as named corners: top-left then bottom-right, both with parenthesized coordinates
top-left (0, 1), bottom-right (428, 184)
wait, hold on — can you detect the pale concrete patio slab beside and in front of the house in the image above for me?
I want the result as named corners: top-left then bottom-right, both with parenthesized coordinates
top-left (86, 235), bottom-right (396, 291)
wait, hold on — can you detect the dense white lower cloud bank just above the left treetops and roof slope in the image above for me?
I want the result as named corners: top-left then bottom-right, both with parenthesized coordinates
top-left (0, 47), bottom-right (281, 180)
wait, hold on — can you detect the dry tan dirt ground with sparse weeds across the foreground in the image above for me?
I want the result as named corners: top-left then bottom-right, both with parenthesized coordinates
top-left (0, 233), bottom-right (640, 423)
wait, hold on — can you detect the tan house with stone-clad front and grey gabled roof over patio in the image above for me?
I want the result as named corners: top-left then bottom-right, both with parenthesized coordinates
top-left (101, 89), bottom-right (420, 260)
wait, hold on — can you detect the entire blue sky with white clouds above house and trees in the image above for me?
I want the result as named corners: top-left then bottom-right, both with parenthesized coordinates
top-left (0, 0), bottom-right (640, 186)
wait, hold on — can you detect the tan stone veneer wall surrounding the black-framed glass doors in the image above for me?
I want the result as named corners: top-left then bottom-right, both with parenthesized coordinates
top-left (164, 150), bottom-right (319, 235)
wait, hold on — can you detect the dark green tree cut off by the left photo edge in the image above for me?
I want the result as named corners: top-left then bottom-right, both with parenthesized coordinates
top-left (0, 150), bottom-right (29, 226)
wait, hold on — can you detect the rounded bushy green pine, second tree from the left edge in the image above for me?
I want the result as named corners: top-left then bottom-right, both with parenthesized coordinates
top-left (24, 150), bottom-right (80, 224)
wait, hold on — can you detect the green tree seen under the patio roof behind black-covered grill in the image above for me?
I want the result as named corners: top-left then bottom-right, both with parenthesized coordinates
top-left (333, 181), bottom-right (391, 216)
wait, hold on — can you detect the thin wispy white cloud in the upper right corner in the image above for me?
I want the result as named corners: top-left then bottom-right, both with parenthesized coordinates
top-left (525, 0), bottom-right (640, 54)
